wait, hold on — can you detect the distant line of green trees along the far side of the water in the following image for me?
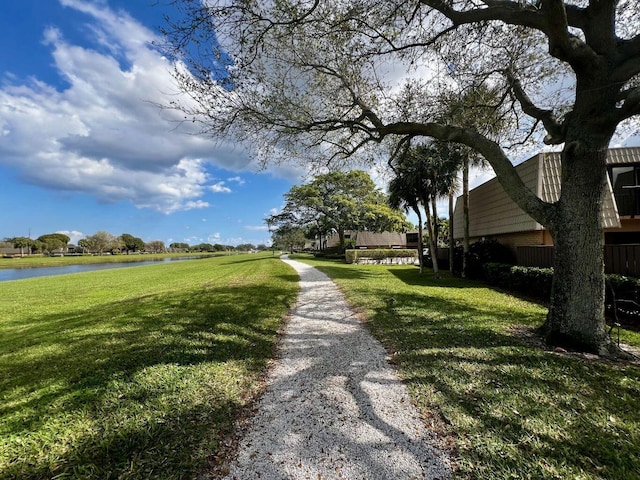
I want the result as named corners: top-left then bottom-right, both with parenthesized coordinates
top-left (0, 230), bottom-right (269, 255)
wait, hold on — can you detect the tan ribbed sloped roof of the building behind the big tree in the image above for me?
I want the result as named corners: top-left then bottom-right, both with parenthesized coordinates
top-left (454, 147), bottom-right (640, 238)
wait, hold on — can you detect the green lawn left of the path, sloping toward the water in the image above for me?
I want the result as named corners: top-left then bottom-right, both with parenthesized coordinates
top-left (0, 254), bottom-right (298, 479)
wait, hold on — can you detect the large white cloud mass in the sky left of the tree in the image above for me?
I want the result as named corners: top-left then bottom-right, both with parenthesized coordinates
top-left (0, 0), bottom-right (258, 214)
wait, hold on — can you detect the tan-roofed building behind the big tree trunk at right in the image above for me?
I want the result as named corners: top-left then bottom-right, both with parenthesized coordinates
top-left (453, 147), bottom-right (640, 274)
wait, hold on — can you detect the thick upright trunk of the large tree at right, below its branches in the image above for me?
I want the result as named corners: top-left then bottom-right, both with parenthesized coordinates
top-left (543, 141), bottom-right (613, 354)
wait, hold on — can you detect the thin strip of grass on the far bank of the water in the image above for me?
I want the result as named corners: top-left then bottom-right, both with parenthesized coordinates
top-left (0, 252), bottom-right (222, 269)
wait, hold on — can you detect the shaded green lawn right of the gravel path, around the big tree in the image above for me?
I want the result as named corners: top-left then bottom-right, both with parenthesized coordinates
top-left (301, 258), bottom-right (640, 479)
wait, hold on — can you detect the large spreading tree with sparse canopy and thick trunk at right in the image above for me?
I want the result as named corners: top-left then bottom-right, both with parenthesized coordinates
top-left (166, 0), bottom-right (640, 352)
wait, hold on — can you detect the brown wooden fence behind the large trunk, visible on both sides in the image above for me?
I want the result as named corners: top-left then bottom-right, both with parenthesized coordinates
top-left (517, 244), bottom-right (640, 277)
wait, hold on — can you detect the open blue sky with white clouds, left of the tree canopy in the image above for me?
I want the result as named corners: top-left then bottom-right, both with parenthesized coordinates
top-left (0, 0), bottom-right (301, 245)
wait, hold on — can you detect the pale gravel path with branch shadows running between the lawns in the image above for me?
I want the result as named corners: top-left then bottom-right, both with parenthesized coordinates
top-left (225, 258), bottom-right (450, 480)
